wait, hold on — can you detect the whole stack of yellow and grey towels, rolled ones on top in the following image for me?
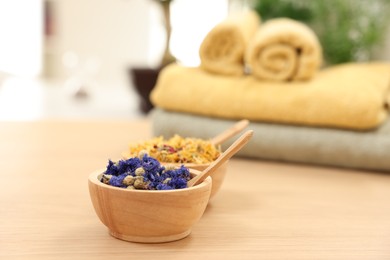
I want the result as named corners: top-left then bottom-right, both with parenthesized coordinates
top-left (150, 12), bottom-right (390, 171)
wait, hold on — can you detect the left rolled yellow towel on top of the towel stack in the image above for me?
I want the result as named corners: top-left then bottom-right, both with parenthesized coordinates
top-left (199, 11), bottom-right (260, 76)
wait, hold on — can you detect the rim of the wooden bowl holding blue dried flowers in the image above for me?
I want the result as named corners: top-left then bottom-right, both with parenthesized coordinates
top-left (88, 169), bottom-right (212, 194)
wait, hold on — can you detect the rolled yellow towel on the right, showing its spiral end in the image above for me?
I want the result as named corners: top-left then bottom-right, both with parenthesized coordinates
top-left (245, 18), bottom-right (322, 81)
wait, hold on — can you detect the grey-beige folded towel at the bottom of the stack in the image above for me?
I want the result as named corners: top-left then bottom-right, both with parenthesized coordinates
top-left (151, 109), bottom-right (390, 171)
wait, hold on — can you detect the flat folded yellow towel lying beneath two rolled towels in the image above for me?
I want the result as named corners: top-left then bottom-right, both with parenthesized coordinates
top-left (150, 62), bottom-right (390, 130)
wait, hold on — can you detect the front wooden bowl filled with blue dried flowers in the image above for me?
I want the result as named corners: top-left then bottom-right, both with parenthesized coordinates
top-left (88, 170), bottom-right (212, 243)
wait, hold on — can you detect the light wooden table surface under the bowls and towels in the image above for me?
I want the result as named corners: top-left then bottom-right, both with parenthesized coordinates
top-left (0, 120), bottom-right (390, 260)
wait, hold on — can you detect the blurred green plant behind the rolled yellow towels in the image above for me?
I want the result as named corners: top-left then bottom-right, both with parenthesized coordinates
top-left (253, 0), bottom-right (390, 65)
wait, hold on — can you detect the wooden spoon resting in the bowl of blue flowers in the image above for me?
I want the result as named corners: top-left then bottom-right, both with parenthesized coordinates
top-left (187, 130), bottom-right (253, 187)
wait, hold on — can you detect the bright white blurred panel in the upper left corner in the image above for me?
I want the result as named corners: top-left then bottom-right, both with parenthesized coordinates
top-left (0, 0), bottom-right (42, 76)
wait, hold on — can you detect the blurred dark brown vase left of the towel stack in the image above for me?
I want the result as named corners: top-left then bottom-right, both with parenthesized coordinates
top-left (130, 68), bottom-right (161, 113)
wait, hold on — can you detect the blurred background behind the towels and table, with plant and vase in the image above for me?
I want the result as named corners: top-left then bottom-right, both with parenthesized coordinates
top-left (0, 0), bottom-right (390, 120)
